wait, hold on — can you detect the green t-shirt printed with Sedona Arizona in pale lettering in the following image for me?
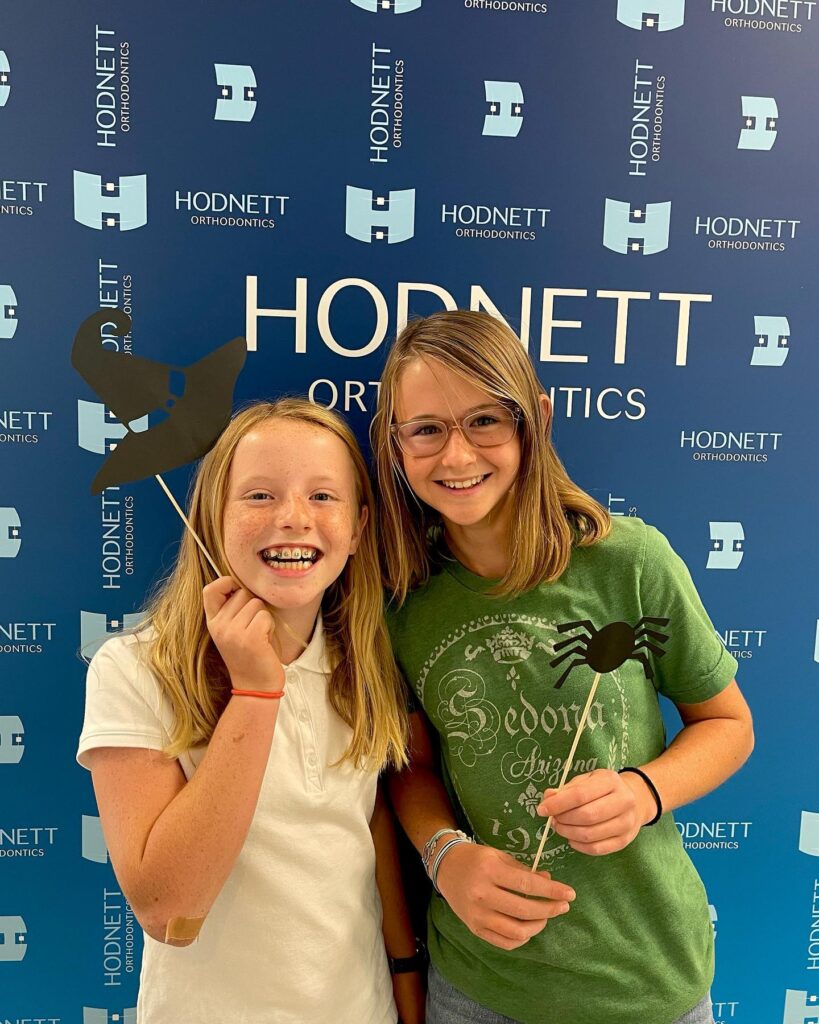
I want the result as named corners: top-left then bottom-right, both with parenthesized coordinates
top-left (389, 518), bottom-right (736, 1024)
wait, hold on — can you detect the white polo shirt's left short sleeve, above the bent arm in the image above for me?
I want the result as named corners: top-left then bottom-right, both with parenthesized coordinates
top-left (77, 634), bottom-right (170, 768)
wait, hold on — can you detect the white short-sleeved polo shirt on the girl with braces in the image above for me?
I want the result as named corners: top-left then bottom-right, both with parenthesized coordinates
top-left (77, 617), bottom-right (396, 1024)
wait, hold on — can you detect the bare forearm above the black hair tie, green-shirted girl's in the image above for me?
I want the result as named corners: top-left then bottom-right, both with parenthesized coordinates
top-left (640, 718), bottom-right (753, 814)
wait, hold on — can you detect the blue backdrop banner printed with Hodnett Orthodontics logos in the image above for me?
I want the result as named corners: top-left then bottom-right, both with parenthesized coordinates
top-left (0, 0), bottom-right (819, 1024)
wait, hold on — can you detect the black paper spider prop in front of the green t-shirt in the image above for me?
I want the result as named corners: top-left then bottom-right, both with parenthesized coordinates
top-left (549, 615), bottom-right (670, 690)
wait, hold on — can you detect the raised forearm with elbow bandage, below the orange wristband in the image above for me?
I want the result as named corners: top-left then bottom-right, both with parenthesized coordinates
top-left (132, 697), bottom-right (279, 938)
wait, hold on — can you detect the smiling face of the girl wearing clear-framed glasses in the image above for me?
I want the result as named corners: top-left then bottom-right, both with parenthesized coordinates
top-left (396, 358), bottom-right (520, 526)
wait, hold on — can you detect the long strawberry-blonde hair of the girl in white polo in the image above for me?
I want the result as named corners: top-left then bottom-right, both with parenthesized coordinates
top-left (146, 398), bottom-right (407, 769)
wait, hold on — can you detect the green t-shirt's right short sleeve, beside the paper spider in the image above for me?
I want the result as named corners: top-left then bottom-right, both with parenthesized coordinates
top-left (640, 526), bottom-right (737, 703)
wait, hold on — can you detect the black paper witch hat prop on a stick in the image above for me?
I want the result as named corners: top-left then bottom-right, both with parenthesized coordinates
top-left (72, 309), bottom-right (248, 495)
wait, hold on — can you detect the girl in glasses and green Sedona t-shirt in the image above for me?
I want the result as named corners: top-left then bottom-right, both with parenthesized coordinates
top-left (373, 311), bottom-right (752, 1024)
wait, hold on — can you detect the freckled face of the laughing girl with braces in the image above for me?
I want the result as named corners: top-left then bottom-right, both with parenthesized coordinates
top-left (223, 420), bottom-right (368, 612)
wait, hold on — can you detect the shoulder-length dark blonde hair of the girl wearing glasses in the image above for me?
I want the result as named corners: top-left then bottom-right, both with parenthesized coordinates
top-left (371, 310), bottom-right (611, 604)
